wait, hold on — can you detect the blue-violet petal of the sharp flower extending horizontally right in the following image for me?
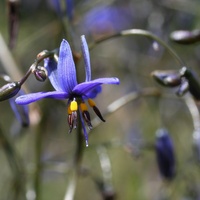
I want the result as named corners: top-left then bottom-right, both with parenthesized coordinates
top-left (73, 77), bottom-right (119, 96)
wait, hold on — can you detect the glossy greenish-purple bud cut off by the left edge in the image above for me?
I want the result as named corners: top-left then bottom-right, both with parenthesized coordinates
top-left (0, 82), bottom-right (21, 101)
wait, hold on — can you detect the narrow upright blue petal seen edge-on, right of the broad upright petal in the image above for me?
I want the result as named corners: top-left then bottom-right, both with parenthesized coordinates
top-left (81, 35), bottom-right (91, 81)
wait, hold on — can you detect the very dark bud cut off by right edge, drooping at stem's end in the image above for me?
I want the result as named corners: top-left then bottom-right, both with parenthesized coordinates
top-left (180, 67), bottom-right (200, 100)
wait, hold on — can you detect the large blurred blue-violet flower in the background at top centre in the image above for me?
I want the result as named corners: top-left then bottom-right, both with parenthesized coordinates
top-left (82, 5), bottom-right (133, 35)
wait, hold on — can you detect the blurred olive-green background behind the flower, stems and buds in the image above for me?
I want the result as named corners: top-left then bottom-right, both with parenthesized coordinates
top-left (0, 0), bottom-right (200, 200)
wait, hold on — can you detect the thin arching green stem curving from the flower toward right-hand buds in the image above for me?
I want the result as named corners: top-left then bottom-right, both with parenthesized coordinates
top-left (89, 29), bottom-right (185, 67)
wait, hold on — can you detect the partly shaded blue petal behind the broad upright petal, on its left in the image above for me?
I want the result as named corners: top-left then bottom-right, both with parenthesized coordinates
top-left (44, 58), bottom-right (62, 91)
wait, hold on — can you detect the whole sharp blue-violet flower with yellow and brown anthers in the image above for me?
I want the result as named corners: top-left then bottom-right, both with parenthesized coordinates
top-left (16, 36), bottom-right (119, 146)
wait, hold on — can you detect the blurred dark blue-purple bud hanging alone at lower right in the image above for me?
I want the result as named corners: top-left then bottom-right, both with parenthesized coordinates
top-left (155, 129), bottom-right (175, 180)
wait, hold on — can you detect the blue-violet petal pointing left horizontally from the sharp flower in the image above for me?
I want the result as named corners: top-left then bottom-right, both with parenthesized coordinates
top-left (15, 91), bottom-right (69, 105)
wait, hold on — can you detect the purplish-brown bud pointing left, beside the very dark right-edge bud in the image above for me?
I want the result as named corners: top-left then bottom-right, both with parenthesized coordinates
top-left (151, 70), bottom-right (181, 87)
